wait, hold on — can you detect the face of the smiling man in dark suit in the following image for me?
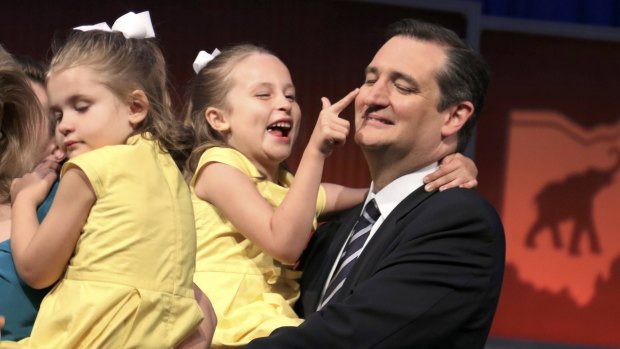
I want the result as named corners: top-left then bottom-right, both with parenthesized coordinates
top-left (355, 36), bottom-right (448, 162)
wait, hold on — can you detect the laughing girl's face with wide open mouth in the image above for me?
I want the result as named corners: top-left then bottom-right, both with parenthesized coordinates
top-left (224, 53), bottom-right (301, 169)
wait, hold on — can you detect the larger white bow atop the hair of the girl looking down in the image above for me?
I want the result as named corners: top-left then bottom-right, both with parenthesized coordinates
top-left (73, 11), bottom-right (155, 39)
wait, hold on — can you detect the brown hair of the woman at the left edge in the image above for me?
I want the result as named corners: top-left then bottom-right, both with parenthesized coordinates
top-left (0, 46), bottom-right (47, 203)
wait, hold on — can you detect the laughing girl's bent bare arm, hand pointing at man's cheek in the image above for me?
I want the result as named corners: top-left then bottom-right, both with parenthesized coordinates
top-left (195, 89), bottom-right (358, 263)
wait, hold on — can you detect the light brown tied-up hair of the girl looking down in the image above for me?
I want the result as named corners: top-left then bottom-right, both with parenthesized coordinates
top-left (48, 30), bottom-right (194, 169)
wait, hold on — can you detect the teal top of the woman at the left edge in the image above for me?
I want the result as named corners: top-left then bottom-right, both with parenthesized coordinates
top-left (0, 181), bottom-right (58, 341)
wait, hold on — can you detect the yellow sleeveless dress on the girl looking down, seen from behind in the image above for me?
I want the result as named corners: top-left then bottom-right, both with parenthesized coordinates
top-left (0, 135), bottom-right (202, 349)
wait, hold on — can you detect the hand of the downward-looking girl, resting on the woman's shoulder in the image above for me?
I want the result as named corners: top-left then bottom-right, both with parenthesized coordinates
top-left (11, 160), bottom-right (59, 205)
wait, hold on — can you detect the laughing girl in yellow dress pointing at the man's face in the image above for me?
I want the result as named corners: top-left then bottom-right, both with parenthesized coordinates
top-left (187, 45), bottom-right (475, 348)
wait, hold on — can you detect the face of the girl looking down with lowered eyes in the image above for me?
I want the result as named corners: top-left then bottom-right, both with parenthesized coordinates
top-left (47, 66), bottom-right (133, 158)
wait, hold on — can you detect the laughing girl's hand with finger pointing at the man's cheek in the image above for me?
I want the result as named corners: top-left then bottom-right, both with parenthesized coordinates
top-left (309, 89), bottom-right (359, 156)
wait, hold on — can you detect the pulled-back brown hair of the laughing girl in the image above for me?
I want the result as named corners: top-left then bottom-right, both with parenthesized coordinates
top-left (184, 44), bottom-right (275, 175)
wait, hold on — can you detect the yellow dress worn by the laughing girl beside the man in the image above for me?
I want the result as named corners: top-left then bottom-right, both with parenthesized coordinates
top-left (190, 147), bottom-right (325, 348)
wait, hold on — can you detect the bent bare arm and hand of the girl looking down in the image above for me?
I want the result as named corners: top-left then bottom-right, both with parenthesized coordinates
top-left (11, 168), bottom-right (96, 288)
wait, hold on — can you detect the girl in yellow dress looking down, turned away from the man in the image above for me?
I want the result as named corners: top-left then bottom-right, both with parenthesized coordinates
top-left (4, 13), bottom-right (208, 348)
